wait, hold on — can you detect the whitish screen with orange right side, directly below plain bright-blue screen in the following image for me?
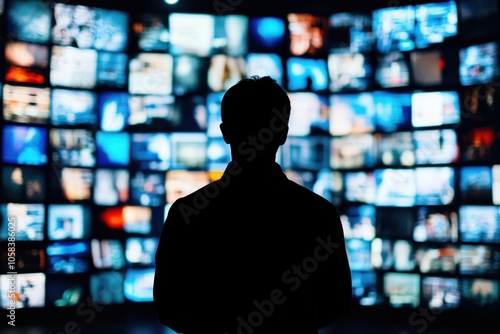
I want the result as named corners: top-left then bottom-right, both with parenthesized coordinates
top-left (94, 168), bottom-right (130, 206)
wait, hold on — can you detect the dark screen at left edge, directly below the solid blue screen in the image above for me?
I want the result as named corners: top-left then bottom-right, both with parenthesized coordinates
top-left (0, 165), bottom-right (47, 203)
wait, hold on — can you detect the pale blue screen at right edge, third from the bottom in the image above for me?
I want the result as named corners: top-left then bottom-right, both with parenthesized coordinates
top-left (458, 205), bottom-right (500, 243)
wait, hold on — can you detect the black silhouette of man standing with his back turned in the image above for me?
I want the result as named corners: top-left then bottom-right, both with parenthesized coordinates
top-left (154, 76), bottom-right (352, 334)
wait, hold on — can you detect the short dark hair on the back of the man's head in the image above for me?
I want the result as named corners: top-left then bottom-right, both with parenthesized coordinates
top-left (221, 76), bottom-right (291, 141)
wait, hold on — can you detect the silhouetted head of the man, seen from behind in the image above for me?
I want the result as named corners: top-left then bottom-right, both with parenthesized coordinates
top-left (220, 76), bottom-right (291, 150)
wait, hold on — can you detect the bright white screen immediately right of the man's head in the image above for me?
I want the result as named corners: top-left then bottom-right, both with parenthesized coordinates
top-left (288, 92), bottom-right (330, 137)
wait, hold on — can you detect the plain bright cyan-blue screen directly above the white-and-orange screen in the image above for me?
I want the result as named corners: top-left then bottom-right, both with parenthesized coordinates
top-left (95, 131), bottom-right (131, 167)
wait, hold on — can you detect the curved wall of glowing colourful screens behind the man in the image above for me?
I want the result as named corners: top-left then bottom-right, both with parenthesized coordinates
top-left (0, 0), bottom-right (500, 322)
